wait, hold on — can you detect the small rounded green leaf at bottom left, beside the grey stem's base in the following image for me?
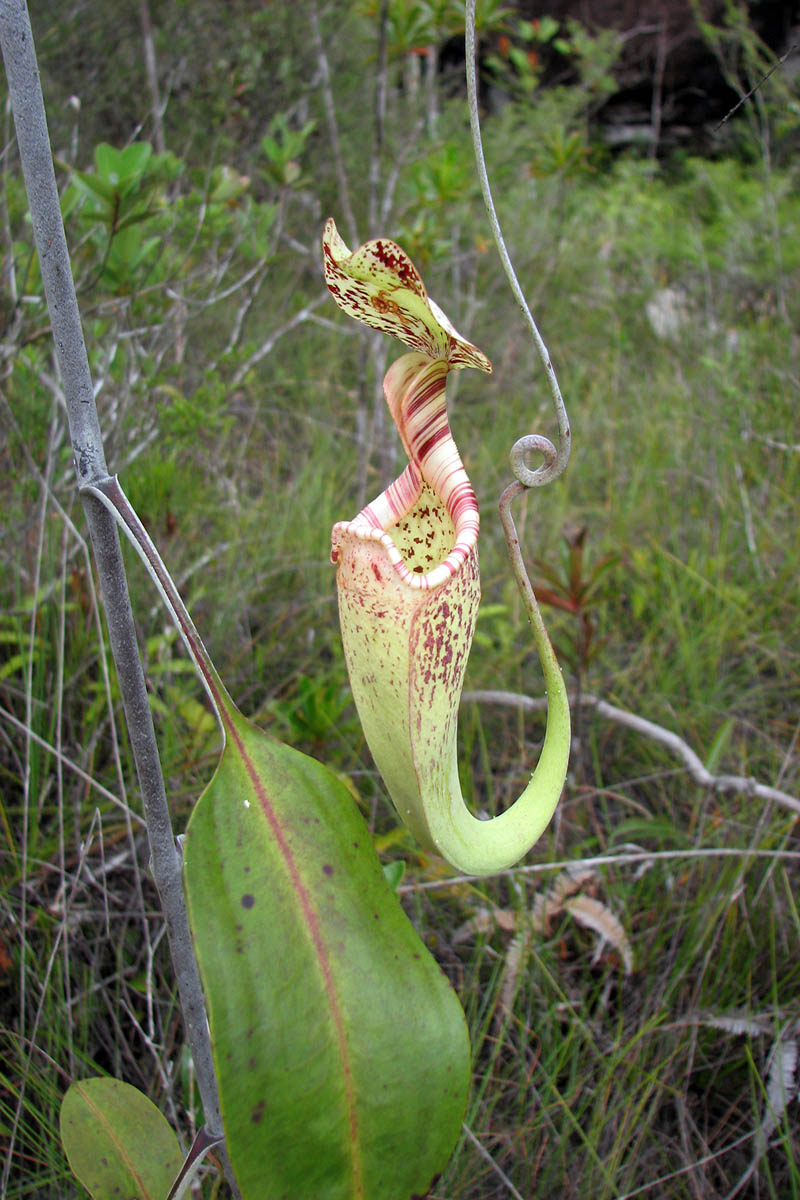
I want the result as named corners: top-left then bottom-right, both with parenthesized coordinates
top-left (60, 1078), bottom-right (184, 1200)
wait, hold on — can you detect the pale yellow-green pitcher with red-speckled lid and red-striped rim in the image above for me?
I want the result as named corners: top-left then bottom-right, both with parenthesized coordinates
top-left (323, 220), bottom-right (570, 875)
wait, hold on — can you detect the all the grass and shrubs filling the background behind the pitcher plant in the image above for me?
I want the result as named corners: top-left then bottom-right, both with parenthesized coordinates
top-left (0, 0), bottom-right (800, 1200)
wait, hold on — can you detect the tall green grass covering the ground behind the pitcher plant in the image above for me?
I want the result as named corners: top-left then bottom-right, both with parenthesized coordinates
top-left (0, 7), bottom-right (800, 1200)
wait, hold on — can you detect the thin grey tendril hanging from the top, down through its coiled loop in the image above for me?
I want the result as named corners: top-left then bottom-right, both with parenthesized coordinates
top-left (467, 0), bottom-right (570, 487)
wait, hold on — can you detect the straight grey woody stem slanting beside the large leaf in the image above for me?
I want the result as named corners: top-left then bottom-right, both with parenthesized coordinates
top-left (0, 0), bottom-right (222, 1135)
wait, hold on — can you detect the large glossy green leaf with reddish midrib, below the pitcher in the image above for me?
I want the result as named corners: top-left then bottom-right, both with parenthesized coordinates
top-left (185, 702), bottom-right (469, 1200)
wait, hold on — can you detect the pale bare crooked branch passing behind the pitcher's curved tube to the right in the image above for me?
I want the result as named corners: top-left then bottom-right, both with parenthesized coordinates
top-left (462, 690), bottom-right (800, 814)
